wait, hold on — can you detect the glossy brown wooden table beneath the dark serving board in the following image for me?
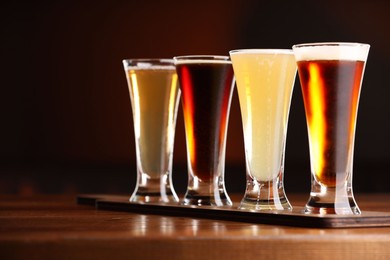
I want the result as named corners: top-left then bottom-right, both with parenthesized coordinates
top-left (0, 194), bottom-right (390, 260)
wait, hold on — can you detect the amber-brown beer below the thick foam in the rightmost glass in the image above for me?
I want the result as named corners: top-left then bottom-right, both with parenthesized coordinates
top-left (298, 60), bottom-right (364, 187)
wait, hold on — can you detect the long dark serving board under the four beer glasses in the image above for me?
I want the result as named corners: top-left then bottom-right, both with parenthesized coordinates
top-left (77, 194), bottom-right (390, 228)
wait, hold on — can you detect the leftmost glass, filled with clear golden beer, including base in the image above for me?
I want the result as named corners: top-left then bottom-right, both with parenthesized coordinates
top-left (123, 59), bottom-right (180, 202)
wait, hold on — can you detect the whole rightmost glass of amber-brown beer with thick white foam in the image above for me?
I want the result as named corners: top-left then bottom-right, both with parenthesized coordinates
top-left (293, 43), bottom-right (370, 214)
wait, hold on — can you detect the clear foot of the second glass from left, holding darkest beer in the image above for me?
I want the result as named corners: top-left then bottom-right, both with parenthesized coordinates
top-left (181, 190), bottom-right (233, 206)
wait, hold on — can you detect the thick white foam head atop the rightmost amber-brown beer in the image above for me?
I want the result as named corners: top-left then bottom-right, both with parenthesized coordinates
top-left (293, 42), bottom-right (370, 61)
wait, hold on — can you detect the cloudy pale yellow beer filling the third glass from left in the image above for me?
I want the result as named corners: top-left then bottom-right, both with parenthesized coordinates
top-left (232, 51), bottom-right (296, 181)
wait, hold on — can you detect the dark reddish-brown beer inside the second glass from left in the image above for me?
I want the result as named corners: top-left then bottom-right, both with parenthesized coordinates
top-left (176, 61), bottom-right (234, 182)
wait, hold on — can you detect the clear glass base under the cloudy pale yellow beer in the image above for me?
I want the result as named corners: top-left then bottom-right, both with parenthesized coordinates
top-left (238, 177), bottom-right (292, 210)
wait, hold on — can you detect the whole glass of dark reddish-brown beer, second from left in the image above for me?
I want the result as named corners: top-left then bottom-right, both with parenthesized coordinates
top-left (174, 56), bottom-right (234, 206)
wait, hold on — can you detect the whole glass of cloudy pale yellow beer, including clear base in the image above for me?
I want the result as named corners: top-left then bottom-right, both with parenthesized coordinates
top-left (230, 49), bottom-right (297, 210)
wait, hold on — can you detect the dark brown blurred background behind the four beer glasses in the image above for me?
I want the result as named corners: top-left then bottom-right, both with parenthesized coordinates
top-left (0, 0), bottom-right (390, 194)
